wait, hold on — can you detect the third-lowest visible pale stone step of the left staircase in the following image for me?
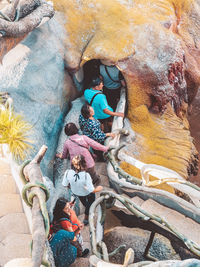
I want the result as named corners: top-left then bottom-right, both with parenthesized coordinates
top-left (0, 194), bottom-right (23, 217)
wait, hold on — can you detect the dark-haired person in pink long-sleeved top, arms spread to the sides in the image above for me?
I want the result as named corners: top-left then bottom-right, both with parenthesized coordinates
top-left (56, 122), bottom-right (109, 185)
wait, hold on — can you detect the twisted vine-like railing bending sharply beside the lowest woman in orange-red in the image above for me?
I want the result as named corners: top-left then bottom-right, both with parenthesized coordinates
top-left (89, 191), bottom-right (200, 262)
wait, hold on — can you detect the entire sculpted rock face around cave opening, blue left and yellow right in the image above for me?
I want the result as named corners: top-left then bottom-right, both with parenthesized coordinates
top-left (0, 0), bottom-right (200, 182)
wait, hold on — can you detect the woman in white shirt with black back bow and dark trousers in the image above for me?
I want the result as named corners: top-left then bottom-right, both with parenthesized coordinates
top-left (62, 155), bottom-right (103, 225)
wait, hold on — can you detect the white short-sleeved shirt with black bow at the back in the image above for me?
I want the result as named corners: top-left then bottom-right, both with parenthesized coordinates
top-left (62, 170), bottom-right (94, 196)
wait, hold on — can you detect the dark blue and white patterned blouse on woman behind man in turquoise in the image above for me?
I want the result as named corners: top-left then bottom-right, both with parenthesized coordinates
top-left (79, 115), bottom-right (106, 144)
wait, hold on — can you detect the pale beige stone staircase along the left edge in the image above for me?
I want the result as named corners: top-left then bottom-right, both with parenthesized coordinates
top-left (0, 154), bottom-right (32, 267)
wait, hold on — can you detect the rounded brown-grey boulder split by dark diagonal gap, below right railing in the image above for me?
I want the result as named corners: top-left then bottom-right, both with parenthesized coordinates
top-left (104, 227), bottom-right (180, 264)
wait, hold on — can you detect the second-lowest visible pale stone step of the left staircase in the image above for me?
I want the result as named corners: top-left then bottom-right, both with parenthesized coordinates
top-left (0, 213), bottom-right (30, 242)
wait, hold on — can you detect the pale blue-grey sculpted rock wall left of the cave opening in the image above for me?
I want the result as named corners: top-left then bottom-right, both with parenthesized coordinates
top-left (0, 14), bottom-right (77, 177)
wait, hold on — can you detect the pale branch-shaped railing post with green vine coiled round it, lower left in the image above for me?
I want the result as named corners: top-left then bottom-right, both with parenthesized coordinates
top-left (20, 145), bottom-right (50, 267)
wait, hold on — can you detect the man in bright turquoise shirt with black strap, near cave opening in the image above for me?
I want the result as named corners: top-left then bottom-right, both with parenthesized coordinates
top-left (84, 77), bottom-right (124, 131)
